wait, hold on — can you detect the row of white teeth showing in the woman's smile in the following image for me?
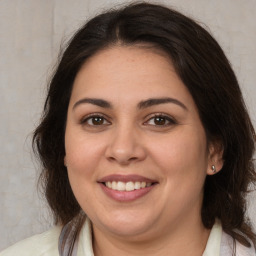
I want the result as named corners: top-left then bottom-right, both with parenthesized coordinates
top-left (105, 181), bottom-right (152, 191)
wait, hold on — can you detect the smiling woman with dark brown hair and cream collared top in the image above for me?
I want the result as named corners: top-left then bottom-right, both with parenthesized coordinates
top-left (1, 3), bottom-right (256, 256)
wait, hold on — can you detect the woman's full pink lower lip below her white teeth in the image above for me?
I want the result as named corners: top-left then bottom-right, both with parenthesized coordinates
top-left (99, 183), bottom-right (155, 202)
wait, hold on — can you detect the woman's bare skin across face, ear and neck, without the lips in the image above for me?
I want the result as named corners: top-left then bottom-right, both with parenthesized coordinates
top-left (64, 46), bottom-right (222, 255)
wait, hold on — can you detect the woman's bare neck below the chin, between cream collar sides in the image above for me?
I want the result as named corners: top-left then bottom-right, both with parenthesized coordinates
top-left (93, 215), bottom-right (210, 256)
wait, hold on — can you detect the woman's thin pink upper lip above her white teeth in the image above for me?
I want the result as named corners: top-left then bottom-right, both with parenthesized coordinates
top-left (98, 174), bottom-right (157, 183)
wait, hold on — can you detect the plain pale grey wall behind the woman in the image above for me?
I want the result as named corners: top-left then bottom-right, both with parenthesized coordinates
top-left (0, 0), bottom-right (256, 250)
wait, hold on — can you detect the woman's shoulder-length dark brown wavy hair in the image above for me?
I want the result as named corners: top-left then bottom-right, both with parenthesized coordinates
top-left (33, 3), bottom-right (256, 251)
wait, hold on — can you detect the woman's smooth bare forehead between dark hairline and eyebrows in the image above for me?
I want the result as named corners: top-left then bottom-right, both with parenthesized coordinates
top-left (71, 46), bottom-right (193, 109)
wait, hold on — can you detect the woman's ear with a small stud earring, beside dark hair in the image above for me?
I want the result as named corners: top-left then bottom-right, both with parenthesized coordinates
top-left (207, 141), bottom-right (224, 175)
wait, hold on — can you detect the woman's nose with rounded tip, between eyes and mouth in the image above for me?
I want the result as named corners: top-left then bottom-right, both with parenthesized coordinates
top-left (106, 127), bottom-right (146, 165)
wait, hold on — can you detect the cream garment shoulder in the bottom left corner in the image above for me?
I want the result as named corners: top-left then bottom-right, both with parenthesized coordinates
top-left (0, 226), bottom-right (61, 256)
